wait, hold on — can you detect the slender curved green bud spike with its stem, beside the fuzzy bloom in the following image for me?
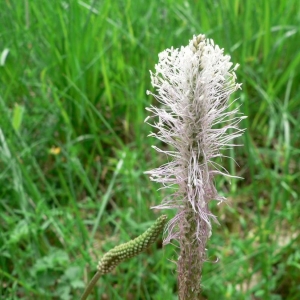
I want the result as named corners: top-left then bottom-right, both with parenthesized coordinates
top-left (81, 215), bottom-right (167, 300)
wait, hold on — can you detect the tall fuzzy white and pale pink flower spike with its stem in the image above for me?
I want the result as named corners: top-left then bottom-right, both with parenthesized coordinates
top-left (145, 35), bottom-right (244, 300)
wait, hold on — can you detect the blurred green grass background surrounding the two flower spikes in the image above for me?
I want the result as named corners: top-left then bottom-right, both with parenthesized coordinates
top-left (0, 0), bottom-right (300, 300)
